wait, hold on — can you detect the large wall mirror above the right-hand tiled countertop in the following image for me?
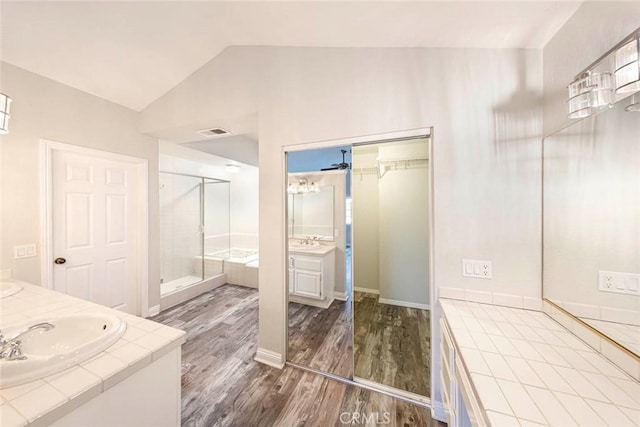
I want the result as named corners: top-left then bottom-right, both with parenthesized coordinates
top-left (543, 96), bottom-right (640, 360)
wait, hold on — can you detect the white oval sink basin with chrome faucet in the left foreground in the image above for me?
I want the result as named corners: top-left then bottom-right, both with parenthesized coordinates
top-left (0, 313), bottom-right (127, 389)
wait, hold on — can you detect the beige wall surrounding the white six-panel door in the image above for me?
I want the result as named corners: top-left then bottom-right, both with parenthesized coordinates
top-left (0, 62), bottom-right (160, 306)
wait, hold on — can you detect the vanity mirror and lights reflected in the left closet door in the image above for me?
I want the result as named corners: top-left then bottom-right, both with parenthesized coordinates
top-left (287, 182), bottom-right (334, 241)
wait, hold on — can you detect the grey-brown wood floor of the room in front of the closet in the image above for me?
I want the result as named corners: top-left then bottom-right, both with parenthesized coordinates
top-left (152, 285), bottom-right (445, 427)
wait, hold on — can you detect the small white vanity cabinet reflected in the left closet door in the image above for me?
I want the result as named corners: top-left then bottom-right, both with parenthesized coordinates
top-left (289, 246), bottom-right (335, 308)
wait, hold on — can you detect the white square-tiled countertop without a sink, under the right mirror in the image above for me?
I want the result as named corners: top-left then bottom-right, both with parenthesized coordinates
top-left (440, 299), bottom-right (640, 427)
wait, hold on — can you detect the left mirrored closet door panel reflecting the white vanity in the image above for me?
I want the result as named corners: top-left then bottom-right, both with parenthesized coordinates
top-left (287, 147), bottom-right (353, 378)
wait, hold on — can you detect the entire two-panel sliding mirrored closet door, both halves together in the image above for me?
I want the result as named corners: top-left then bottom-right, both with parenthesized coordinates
top-left (287, 131), bottom-right (431, 402)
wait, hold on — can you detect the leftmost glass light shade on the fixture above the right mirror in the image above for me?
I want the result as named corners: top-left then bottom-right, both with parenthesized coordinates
top-left (567, 73), bottom-right (612, 119)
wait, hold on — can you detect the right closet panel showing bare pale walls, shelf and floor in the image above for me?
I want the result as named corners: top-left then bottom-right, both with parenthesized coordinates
top-left (352, 139), bottom-right (431, 400)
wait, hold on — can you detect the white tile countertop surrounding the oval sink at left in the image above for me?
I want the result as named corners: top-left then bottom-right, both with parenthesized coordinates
top-left (0, 282), bottom-right (186, 427)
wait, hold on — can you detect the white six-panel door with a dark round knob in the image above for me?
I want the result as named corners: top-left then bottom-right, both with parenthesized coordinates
top-left (42, 141), bottom-right (148, 316)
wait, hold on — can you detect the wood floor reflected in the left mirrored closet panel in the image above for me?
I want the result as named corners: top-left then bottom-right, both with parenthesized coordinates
top-left (287, 300), bottom-right (353, 379)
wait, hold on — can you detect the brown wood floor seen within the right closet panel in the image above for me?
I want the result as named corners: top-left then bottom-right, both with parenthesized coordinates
top-left (354, 292), bottom-right (431, 397)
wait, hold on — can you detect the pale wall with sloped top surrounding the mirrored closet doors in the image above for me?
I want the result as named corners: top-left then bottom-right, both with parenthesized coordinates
top-left (141, 47), bottom-right (542, 412)
